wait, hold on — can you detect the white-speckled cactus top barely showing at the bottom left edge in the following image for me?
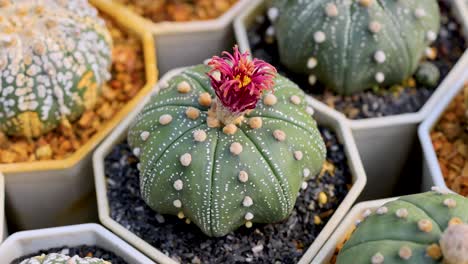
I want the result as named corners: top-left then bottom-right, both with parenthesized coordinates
top-left (20, 253), bottom-right (111, 264)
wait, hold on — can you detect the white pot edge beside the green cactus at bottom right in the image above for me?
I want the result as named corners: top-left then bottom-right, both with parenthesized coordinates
top-left (311, 198), bottom-right (397, 264)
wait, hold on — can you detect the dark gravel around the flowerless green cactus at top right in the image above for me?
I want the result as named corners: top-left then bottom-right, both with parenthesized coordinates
top-left (248, 0), bottom-right (467, 119)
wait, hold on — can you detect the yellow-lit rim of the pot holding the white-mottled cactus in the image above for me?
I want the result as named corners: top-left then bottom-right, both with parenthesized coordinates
top-left (0, 0), bottom-right (158, 174)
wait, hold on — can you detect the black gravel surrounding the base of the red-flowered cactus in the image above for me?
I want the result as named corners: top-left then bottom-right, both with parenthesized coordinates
top-left (105, 127), bottom-right (351, 263)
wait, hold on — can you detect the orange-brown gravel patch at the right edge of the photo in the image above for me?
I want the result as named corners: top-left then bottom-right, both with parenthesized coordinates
top-left (431, 83), bottom-right (468, 197)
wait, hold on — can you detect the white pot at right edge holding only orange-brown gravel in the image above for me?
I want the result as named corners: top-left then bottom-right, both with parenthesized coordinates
top-left (418, 72), bottom-right (468, 191)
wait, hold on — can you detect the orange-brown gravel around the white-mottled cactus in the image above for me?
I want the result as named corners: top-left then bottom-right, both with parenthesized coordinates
top-left (0, 15), bottom-right (145, 163)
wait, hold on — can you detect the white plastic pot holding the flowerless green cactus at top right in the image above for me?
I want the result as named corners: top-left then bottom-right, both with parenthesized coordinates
top-left (234, 0), bottom-right (468, 200)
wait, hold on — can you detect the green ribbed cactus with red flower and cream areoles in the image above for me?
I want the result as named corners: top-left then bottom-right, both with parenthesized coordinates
top-left (128, 47), bottom-right (326, 236)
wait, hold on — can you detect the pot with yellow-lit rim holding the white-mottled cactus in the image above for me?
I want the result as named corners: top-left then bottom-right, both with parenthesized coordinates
top-left (0, 0), bottom-right (158, 230)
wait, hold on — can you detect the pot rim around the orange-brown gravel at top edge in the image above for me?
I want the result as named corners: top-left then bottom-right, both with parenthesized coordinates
top-left (90, 0), bottom-right (251, 35)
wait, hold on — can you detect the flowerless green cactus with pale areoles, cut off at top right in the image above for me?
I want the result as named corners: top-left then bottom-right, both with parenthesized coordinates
top-left (270, 0), bottom-right (440, 95)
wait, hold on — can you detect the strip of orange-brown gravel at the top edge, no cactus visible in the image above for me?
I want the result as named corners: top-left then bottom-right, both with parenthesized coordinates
top-left (117, 0), bottom-right (237, 22)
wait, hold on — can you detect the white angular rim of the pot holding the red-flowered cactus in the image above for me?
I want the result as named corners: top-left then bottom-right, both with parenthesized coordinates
top-left (93, 67), bottom-right (366, 263)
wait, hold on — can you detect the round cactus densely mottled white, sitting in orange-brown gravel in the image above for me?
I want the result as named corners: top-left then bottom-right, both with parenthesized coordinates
top-left (0, 0), bottom-right (112, 138)
